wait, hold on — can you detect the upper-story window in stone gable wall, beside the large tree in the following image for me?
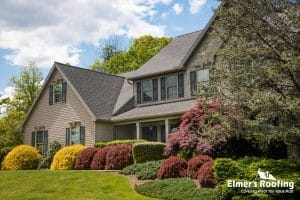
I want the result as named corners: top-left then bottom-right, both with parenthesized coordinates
top-left (190, 69), bottom-right (209, 95)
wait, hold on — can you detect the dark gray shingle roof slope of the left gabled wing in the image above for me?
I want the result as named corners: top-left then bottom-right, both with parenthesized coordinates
top-left (55, 62), bottom-right (125, 119)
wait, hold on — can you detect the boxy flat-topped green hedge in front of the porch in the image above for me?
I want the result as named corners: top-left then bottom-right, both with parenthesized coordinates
top-left (132, 142), bottom-right (165, 163)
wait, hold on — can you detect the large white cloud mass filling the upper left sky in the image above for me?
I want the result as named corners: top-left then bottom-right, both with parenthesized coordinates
top-left (0, 0), bottom-right (166, 68)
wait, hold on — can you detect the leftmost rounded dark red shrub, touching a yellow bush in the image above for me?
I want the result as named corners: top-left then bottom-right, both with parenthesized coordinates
top-left (75, 147), bottom-right (99, 169)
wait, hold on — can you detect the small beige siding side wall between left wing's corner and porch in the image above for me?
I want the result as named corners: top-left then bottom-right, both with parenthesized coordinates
top-left (95, 122), bottom-right (113, 142)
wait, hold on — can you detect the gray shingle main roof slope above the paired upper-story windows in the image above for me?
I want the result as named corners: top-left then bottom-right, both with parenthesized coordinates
top-left (128, 31), bottom-right (201, 79)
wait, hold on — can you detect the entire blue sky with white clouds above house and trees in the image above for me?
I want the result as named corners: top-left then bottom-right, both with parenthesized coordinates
top-left (0, 0), bottom-right (219, 98)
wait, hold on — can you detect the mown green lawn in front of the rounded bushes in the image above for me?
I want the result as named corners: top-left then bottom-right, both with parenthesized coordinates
top-left (0, 170), bottom-right (158, 200)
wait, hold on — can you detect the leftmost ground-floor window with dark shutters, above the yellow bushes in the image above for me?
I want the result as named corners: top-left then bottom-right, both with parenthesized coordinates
top-left (31, 130), bottom-right (48, 156)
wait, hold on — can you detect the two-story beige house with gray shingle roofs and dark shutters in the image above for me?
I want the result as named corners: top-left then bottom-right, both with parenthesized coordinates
top-left (22, 16), bottom-right (221, 153)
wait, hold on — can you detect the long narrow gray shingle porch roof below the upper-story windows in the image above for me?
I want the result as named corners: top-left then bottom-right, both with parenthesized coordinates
top-left (111, 99), bottom-right (195, 122)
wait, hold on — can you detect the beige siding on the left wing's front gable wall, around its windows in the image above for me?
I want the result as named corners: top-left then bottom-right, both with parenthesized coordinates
top-left (24, 69), bottom-right (95, 146)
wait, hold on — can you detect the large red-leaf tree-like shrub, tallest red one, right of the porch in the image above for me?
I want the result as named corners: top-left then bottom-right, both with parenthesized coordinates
top-left (164, 99), bottom-right (232, 157)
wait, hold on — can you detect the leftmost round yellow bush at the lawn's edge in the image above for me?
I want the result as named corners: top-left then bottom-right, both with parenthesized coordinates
top-left (2, 145), bottom-right (42, 170)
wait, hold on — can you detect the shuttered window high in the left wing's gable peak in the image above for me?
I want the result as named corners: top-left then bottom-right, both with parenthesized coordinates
top-left (49, 80), bottom-right (67, 105)
